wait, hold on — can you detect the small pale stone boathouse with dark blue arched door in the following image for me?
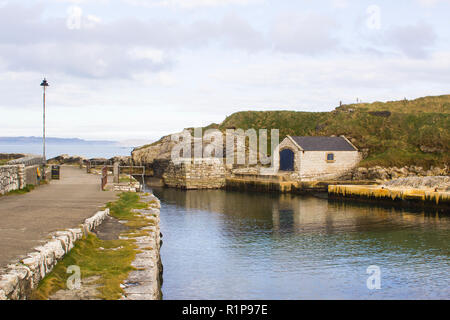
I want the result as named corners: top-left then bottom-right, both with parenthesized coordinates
top-left (273, 136), bottom-right (361, 179)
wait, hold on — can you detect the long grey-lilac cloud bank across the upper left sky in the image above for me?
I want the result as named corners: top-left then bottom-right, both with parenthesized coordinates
top-left (0, 5), bottom-right (265, 78)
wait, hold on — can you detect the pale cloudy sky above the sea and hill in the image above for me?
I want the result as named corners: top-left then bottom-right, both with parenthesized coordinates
top-left (0, 0), bottom-right (450, 142)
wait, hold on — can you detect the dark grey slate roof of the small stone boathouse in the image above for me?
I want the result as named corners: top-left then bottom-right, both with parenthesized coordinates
top-left (291, 136), bottom-right (358, 151)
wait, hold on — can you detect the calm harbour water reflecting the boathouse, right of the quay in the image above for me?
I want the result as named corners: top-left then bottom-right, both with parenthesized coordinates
top-left (153, 188), bottom-right (450, 299)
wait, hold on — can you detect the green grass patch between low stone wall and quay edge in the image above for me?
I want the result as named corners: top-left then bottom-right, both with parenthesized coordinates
top-left (32, 192), bottom-right (150, 300)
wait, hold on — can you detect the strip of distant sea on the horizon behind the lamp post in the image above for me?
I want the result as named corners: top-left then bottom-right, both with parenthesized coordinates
top-left (0, 143), bottom-right (133, 159)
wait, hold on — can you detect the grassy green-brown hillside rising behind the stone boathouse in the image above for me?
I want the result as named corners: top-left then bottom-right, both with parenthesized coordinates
top-left (136, 95), bottom-right (450, 168)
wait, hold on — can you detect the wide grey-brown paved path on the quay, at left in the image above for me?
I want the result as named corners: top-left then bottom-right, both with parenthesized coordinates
top-left (0, 166), bottom-right (117, 268)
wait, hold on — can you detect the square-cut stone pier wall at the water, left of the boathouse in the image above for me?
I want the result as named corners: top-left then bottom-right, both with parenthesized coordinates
top-left (163, 158), bottom-right (226, 189)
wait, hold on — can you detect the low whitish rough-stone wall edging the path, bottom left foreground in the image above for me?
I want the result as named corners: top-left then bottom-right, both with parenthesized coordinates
top-left (0, 209), bottom-right (109, 300)
